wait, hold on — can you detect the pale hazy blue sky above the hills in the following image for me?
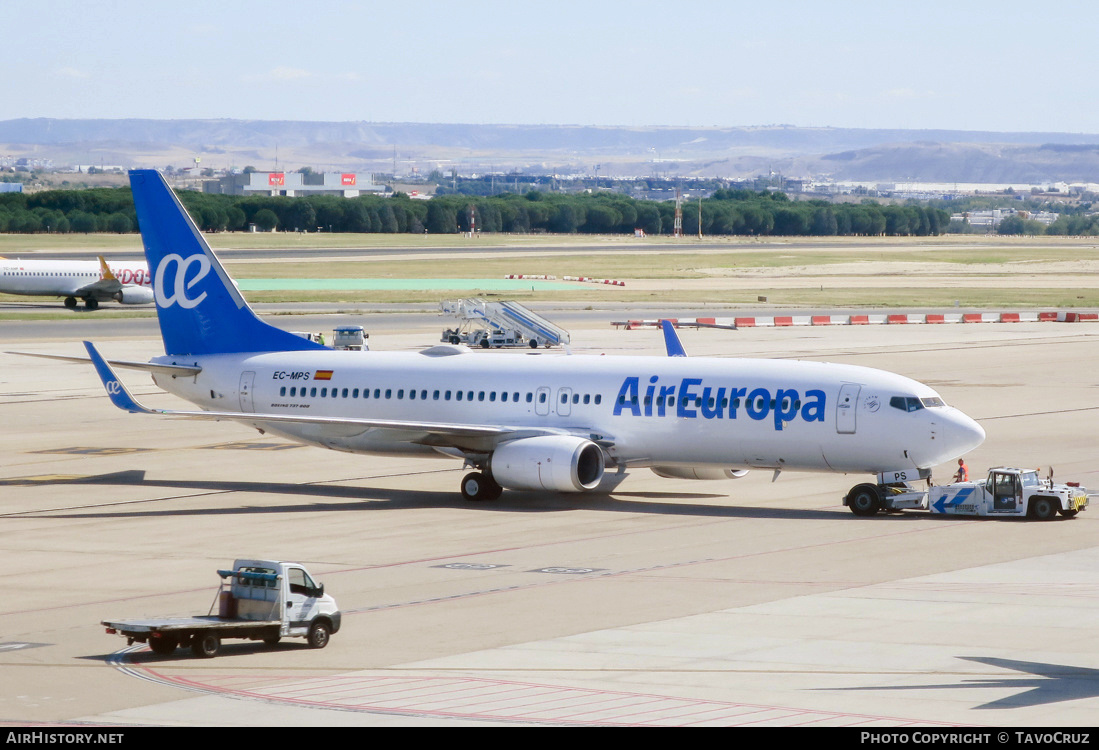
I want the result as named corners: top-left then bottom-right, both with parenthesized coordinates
top-left (8, 0), bottom-right (1099, 133)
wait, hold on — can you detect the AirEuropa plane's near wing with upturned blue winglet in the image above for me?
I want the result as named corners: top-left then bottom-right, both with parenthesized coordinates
top-left (84, 341), bottom-right (610, 451)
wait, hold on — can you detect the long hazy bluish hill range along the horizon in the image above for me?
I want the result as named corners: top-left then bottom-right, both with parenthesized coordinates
top-left (0, 119), bottom-right (1099, 183)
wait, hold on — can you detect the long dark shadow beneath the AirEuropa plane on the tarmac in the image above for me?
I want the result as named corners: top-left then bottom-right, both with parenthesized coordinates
top-left (4, 470), bottom-right (852, 521)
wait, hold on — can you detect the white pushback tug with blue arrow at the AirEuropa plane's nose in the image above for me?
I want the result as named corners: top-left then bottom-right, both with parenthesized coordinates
top-left (843, 467), bottom-right (1090, 521)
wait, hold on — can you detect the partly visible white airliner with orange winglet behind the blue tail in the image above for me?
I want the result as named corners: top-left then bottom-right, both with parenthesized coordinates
top-left (0, 256), bottom-right (153, 310)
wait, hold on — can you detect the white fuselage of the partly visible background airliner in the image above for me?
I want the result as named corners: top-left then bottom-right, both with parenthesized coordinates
top-left (0, 258), bottom-right (152, 299)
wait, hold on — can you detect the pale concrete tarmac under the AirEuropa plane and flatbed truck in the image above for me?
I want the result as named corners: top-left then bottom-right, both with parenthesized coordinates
top-left (0, 313), bottom-right (1099, 727)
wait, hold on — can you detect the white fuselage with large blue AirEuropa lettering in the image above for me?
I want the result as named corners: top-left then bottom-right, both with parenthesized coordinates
top-left (154, 346), bottom-right (984, 473)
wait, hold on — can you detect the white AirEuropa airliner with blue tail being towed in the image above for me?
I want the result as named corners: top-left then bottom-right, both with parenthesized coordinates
top-left (42, 170), bottom-right (985, 499)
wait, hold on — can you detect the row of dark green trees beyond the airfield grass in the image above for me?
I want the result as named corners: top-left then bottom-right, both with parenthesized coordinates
top-left (0, 183), bottom-right (967, 236)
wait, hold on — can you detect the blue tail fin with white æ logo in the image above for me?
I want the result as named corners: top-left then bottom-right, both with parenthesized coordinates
top-left (130, 169), bottom-right (323, 354)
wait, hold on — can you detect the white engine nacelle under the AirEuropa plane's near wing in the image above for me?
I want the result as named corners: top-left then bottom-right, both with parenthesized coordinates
top-left (489, 435), bottom-right (606, 493)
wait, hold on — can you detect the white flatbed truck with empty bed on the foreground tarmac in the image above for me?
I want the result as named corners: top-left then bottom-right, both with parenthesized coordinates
top-left (102, 560), bottom-right (341, 659)
